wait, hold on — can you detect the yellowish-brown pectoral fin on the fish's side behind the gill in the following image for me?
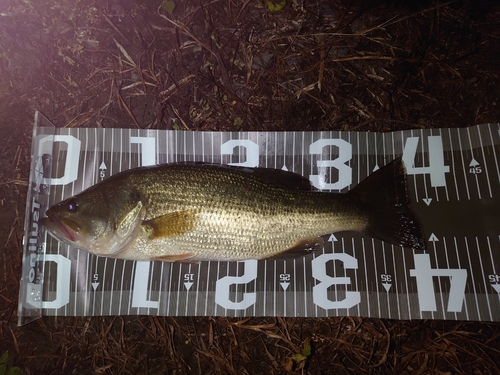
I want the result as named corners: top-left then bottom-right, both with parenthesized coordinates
top-left (142, 210), bottom-right (195, 240)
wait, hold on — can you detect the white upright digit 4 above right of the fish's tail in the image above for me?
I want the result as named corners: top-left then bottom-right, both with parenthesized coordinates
top-left (403, 135), bottom-right (450, 187)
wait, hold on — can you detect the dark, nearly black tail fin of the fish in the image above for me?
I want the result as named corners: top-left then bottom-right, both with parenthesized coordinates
top-left (350, 158), bottom-right (426, 250)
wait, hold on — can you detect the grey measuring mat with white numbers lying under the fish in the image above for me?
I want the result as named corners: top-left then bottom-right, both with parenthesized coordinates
top-left (19, 115), bottom-right (500, 324)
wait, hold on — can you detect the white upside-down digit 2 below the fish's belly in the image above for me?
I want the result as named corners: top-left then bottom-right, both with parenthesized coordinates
top-left (215, 260), bottom-right (257, 310)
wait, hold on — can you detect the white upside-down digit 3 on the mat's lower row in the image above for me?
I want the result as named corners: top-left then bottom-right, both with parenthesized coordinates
top-left (311, 253), bottom-right (361, 310)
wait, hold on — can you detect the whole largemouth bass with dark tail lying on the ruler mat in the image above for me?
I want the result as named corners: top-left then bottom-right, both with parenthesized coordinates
top-left (42, 158), bottom-right (426, 263)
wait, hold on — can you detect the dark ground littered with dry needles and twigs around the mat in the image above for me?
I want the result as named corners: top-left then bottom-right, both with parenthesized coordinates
top-left (0, 0), bottom-right (500, 375)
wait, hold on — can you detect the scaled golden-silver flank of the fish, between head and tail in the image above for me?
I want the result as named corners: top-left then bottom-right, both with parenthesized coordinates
top-left (127, 165), bottom-right (366, 260)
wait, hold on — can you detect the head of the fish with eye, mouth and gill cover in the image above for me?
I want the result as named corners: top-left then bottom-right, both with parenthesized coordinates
top-left (42, 184), bottom-right (146, 257)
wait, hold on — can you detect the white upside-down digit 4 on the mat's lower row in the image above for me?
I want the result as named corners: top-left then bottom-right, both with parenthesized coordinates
top-left (410, 254), bottom-right (467, 312)
